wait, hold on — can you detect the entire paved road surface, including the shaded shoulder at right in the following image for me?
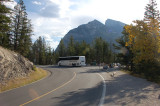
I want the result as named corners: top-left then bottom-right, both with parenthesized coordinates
top-left (0, 66), bottom-right (160, 106)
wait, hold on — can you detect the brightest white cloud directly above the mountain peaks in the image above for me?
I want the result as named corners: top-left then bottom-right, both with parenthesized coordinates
top-left (69, 0), bottom-right (148, 24)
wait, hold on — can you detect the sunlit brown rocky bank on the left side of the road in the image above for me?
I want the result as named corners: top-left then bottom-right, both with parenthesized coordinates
top-left (0, 47), bottom-right (33, 83)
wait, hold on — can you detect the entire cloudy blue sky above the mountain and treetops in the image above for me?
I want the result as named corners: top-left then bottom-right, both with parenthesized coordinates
top-left (10, 0), bottom-right (160, 49)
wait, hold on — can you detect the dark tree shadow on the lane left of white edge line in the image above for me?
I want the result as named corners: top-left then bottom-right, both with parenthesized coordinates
top-left (52, 83), bottom-right (103, 106)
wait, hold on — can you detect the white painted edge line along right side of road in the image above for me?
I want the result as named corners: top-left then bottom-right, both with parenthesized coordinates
top-left (97, 73), bottom-right (106, 106)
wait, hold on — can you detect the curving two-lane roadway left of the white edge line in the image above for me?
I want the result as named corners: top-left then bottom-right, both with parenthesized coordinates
top-left (0, 66), bottom-right (106, 106)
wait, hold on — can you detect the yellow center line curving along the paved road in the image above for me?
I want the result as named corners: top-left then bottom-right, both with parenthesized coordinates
top-left (19, 72), bottom-right (76, 106)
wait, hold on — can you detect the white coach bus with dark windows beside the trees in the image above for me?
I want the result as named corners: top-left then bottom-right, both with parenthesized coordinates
top-left (58, 56), bottom-right (86, 66)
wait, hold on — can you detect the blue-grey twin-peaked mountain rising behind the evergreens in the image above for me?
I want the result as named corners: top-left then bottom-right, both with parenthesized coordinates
top-left (57, 19), bottom-right (125, 48)
